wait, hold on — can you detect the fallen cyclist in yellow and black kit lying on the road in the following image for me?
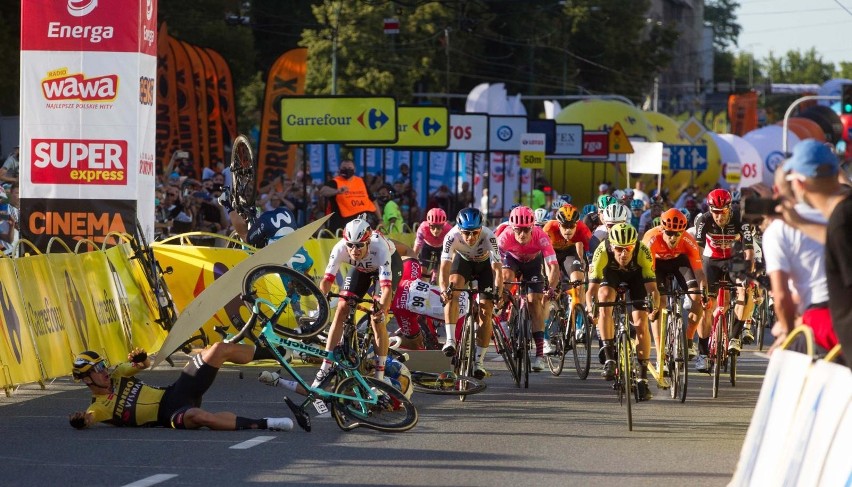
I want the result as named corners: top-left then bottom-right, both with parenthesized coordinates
top-left (68, 343), bottom-right (293, 431)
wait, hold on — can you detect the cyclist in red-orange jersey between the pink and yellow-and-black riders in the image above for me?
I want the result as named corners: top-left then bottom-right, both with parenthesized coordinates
top-left (544, 204), bottom-right (592, 298)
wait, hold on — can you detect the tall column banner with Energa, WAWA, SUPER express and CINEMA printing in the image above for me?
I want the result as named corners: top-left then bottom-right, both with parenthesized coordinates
top-left (20, 0), bottom-right (157, 249)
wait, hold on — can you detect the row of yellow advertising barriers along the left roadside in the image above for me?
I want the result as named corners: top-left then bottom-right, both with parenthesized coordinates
top-left (0, 231), bottom-right (414, 395)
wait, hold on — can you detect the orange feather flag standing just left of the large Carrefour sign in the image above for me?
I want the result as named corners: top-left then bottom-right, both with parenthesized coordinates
top-left (257, 48), bottom-right (308, 181)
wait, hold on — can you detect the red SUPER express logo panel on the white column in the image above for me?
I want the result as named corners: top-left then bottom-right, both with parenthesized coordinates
top-left (31, 139), bottom-right (127, 185)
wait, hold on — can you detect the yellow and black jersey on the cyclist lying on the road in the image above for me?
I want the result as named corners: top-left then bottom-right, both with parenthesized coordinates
top-left (86, 362), bottom-right (166, 426)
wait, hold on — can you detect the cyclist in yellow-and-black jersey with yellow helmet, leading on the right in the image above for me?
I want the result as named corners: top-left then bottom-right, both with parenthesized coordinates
top-left (586, 223), bottom-right (660, 400)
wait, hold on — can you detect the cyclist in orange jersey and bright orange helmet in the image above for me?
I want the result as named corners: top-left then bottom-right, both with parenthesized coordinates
top-left (642, 208), bottom-right (707, 368)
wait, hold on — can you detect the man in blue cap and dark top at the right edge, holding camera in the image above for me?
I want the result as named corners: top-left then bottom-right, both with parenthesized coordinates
top-left (778, 139), bottom-right (852, 366)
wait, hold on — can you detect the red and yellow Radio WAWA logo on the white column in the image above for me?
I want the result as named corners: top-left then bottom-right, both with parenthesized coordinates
top-left (41, 68), bottom-right (118, 108)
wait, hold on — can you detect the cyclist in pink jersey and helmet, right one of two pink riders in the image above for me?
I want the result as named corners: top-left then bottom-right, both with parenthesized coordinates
top-left (497, 206), bottom-right (560, 372)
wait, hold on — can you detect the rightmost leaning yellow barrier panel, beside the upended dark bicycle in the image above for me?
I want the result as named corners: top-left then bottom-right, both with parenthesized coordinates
top-left (104, 243), bottom-right (166, 354)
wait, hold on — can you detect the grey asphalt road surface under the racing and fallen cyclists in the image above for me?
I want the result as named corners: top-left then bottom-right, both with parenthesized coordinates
top-left (0, 347), bottom-right (767, 487)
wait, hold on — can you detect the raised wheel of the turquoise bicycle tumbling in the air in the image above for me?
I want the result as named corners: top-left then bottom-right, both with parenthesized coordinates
top-left (242, 265), bottom-right (329, 339)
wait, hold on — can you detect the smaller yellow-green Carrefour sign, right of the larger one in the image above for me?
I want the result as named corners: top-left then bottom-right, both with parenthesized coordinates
top-left (362, 107), bottom-right (450, 149)
